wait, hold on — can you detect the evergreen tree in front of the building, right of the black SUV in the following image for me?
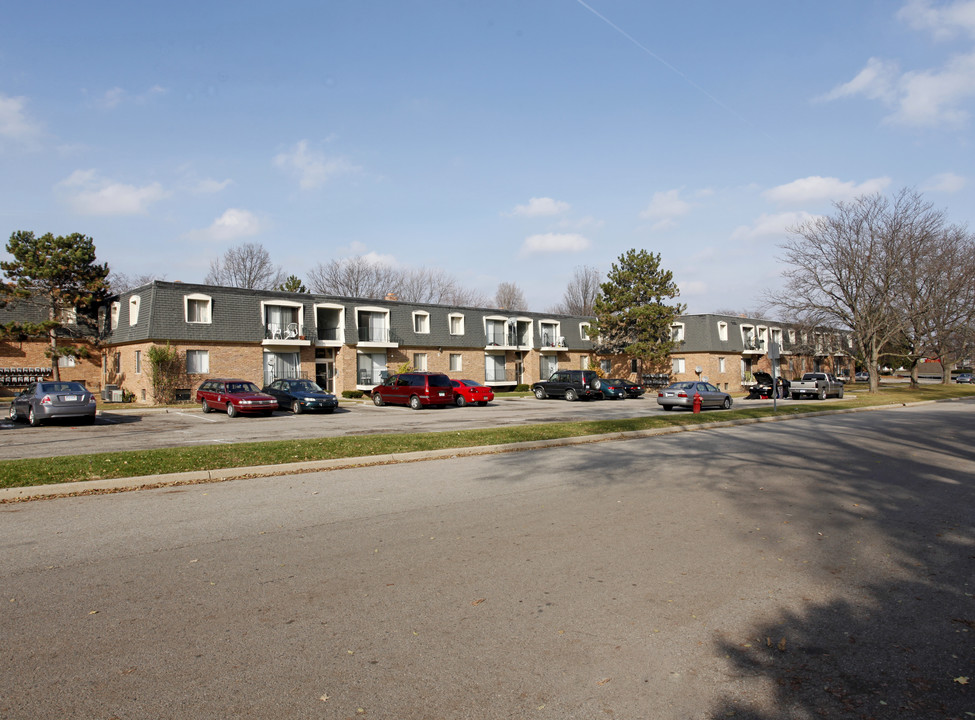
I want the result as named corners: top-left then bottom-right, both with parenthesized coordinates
top-left (590, 250), bottom-right (686, 372)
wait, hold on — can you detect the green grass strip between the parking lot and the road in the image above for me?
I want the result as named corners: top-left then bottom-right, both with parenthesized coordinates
top-left (0, 385), bottom-right (975, 488)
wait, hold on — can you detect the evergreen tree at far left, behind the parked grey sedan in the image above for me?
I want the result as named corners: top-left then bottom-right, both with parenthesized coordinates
top-left (0, 230), bottom-right (108, 380)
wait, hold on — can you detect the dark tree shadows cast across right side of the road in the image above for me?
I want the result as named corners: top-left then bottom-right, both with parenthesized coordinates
top-left (474, 403), bottom-right (975, 720)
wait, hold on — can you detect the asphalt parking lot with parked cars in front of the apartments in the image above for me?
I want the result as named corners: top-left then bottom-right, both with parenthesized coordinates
top-left (0, 394), bottom-right (801, 460)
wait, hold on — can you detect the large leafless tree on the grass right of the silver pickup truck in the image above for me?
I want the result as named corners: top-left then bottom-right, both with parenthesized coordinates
top-left (767, 189), bottom-right (943, 392)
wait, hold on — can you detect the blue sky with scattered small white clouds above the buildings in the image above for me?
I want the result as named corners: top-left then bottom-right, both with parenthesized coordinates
top-left (0, 0), bottom-right (975, 312)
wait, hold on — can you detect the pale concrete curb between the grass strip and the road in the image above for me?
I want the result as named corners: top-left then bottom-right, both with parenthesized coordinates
top-left (0, 398), bottom-right (966, 504)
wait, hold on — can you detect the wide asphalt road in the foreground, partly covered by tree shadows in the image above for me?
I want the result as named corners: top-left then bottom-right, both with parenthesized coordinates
top-left (0, 402), bottom-right (975, 720)
